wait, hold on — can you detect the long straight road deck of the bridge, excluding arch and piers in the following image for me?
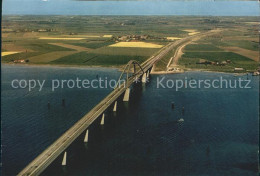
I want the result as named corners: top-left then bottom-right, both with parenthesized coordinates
top-left (18, 31), bottom-right (218, 176)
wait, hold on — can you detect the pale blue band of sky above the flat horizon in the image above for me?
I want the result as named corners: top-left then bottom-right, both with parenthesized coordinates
top-left (2, 0), bottom-right (260, 16)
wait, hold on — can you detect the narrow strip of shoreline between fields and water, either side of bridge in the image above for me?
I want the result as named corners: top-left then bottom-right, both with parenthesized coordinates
top-left (1, 63), bottom-right (251, 75)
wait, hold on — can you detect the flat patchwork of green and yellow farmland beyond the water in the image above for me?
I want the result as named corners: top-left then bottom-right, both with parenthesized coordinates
top-left (2, 16), bottom-right (259, 72)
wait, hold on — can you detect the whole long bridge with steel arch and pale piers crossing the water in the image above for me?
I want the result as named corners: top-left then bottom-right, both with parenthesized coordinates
top-left (18, 31), bottom-right (219, 176)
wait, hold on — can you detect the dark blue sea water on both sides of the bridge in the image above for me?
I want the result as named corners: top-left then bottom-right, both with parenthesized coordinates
top-left (1, 65), bottom-right (259, 176)
